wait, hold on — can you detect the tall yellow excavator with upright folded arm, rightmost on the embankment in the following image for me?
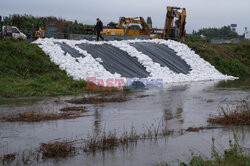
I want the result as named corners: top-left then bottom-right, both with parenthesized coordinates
top-left (163, 7), bottom-right (186, 40)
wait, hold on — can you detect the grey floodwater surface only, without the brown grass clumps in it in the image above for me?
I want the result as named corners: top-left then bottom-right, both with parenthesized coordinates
top-left (0, 78), bottom-right (250, 166)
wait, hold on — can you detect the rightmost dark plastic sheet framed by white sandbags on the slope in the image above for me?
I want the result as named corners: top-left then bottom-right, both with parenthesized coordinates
top-left (130, 42), bottom-right (191, 74)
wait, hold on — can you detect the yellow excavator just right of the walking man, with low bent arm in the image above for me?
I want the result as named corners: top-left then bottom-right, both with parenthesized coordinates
top-left (103, 17), bottom-right (151, 35)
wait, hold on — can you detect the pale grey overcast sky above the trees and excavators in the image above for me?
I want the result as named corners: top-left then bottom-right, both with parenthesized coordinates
top-left (0, 0), bottom-right (250, 34)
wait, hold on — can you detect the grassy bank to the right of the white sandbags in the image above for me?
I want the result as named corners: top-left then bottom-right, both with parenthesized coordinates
top-left (185, 41), bottom-right (250, 77)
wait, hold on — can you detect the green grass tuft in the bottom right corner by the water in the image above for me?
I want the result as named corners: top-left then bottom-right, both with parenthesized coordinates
top-left (156, 135), bottom-right (250, 166)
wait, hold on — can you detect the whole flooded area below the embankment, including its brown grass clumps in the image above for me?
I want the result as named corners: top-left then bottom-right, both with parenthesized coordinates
top-left (0, 78), bottom-right (250, 166)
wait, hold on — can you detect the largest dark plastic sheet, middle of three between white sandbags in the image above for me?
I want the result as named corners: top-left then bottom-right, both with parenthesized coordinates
top-left (76, 44), bottom-right (149, 78)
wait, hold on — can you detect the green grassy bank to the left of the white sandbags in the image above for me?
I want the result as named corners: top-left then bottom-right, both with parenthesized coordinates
top-left (0, 40), bottom-right (96, 98)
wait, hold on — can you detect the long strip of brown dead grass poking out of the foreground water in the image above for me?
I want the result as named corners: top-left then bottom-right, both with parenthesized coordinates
top-left (0, 126), bottom-right (173, 165)
